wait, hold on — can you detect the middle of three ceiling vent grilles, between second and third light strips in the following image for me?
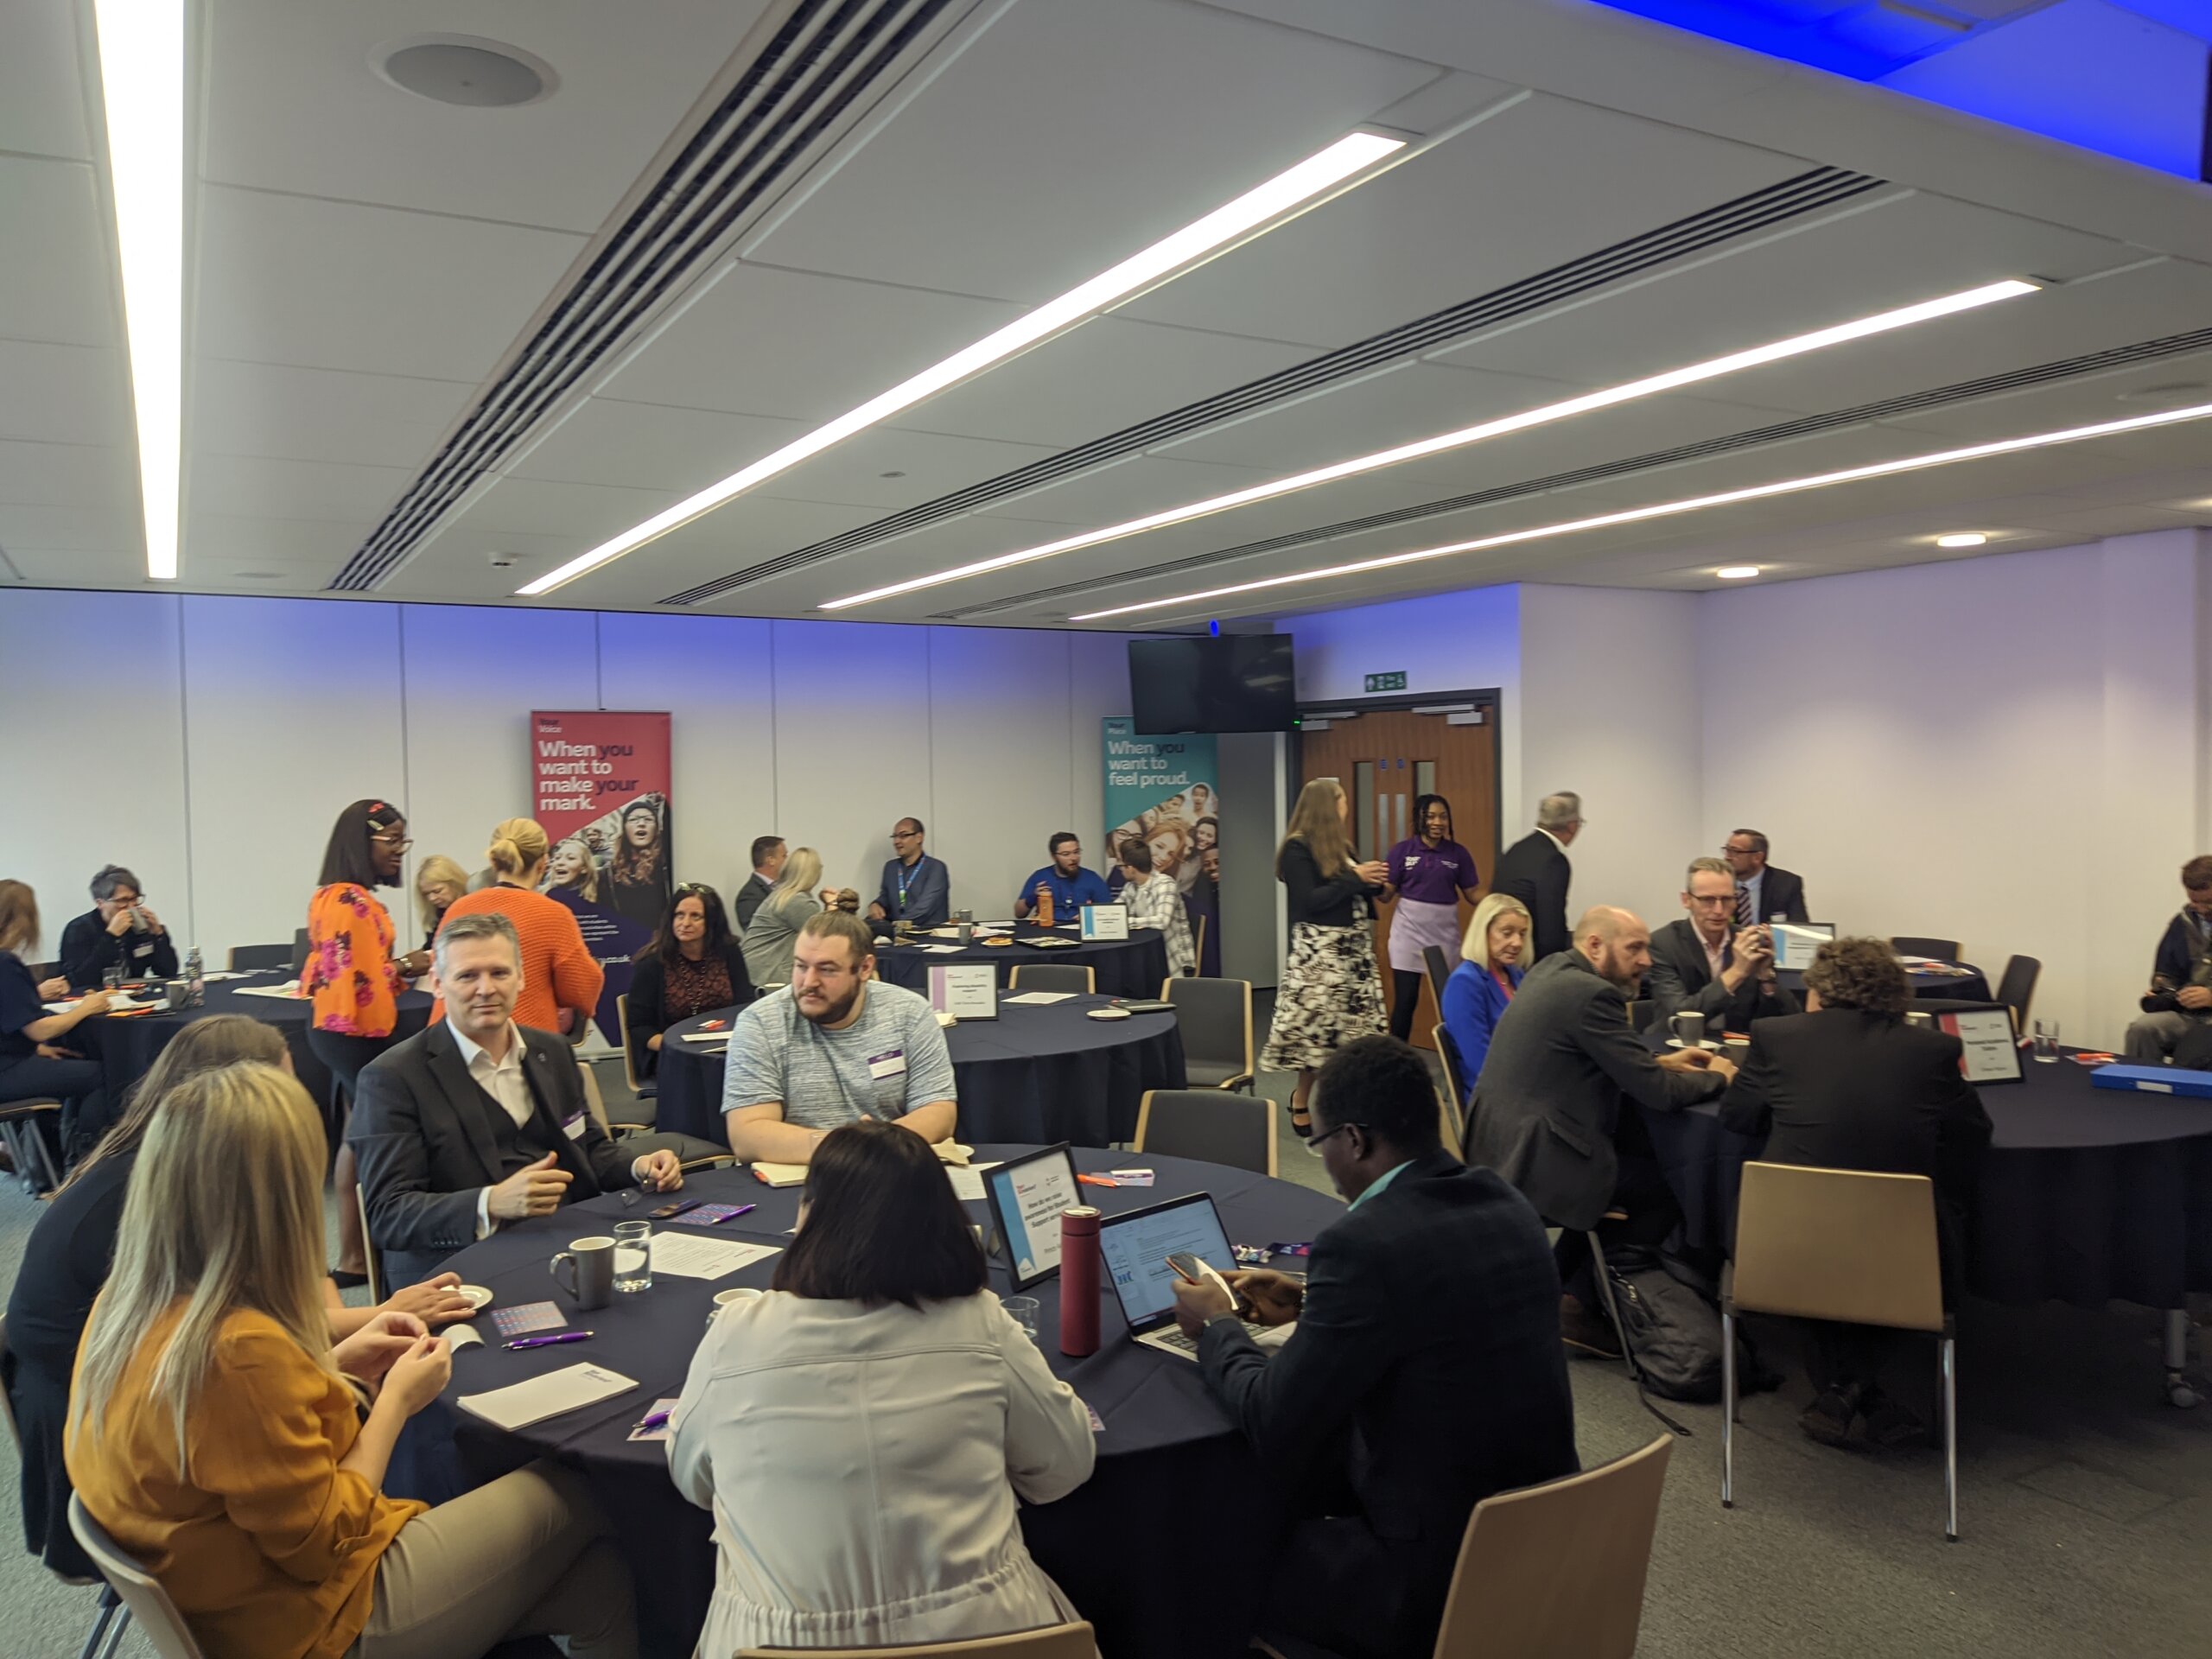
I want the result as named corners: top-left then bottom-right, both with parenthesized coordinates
top-left (661, 168), bottom-right (1883, 606)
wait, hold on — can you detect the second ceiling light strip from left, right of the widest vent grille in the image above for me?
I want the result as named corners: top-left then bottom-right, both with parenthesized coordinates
top-left (520, 133), bottom-right (1405, 595)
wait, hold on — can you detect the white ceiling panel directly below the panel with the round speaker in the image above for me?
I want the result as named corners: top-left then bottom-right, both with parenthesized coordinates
top-left (194, 188), bottom-right (584, 380)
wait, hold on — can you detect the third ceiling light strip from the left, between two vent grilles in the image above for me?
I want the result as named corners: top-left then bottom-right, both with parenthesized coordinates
top-left (823, 276), bottom-right (2039, 611)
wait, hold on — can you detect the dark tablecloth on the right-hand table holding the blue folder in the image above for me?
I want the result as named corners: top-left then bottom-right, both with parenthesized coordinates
top-left (1643, 1055), bottom-right (2212, 1307)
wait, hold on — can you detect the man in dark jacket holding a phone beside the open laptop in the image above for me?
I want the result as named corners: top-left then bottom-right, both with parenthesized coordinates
top-left (1177, 1038), bottom-right (1577, 1659)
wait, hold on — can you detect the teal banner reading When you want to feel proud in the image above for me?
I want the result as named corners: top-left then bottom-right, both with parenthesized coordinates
top-left (1103, 719), bottom-right (1221, 978)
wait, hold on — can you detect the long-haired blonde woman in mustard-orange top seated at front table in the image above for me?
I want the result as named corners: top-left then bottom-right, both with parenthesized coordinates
top-left (68, 1062), bottom-right (637, 1659)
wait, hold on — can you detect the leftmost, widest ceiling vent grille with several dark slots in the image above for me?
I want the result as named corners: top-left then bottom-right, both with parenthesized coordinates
top-left (332, 0), bottom-right (953, 591)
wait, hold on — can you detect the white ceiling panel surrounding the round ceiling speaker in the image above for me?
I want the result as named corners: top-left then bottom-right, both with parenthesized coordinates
top-left (206, 0), bottom-right (767, 232)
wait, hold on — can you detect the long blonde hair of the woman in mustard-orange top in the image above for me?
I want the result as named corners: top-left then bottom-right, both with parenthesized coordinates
top-left (68, 1059), bottom-right (329, 1465)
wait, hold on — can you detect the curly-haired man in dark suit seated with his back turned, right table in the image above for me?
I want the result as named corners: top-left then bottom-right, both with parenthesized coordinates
top-left (1721, 938), bottom-right (1988, 1445)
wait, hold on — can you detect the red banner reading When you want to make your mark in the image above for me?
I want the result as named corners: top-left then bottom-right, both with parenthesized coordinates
top-left (531, 710), bottom-right (675, 1044)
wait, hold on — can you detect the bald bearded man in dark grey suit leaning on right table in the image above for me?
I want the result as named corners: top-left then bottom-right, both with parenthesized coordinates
top-left (1466, 905), bottom-right (1737, 1354)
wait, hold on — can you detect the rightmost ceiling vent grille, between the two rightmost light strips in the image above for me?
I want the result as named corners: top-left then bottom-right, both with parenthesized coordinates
top-left (931, 327), bottom-right (2212, 621)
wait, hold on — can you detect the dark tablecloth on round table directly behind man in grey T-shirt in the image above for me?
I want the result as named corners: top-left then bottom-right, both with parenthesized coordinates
top-left (652, 995), bottom-right (1184, 1146)
